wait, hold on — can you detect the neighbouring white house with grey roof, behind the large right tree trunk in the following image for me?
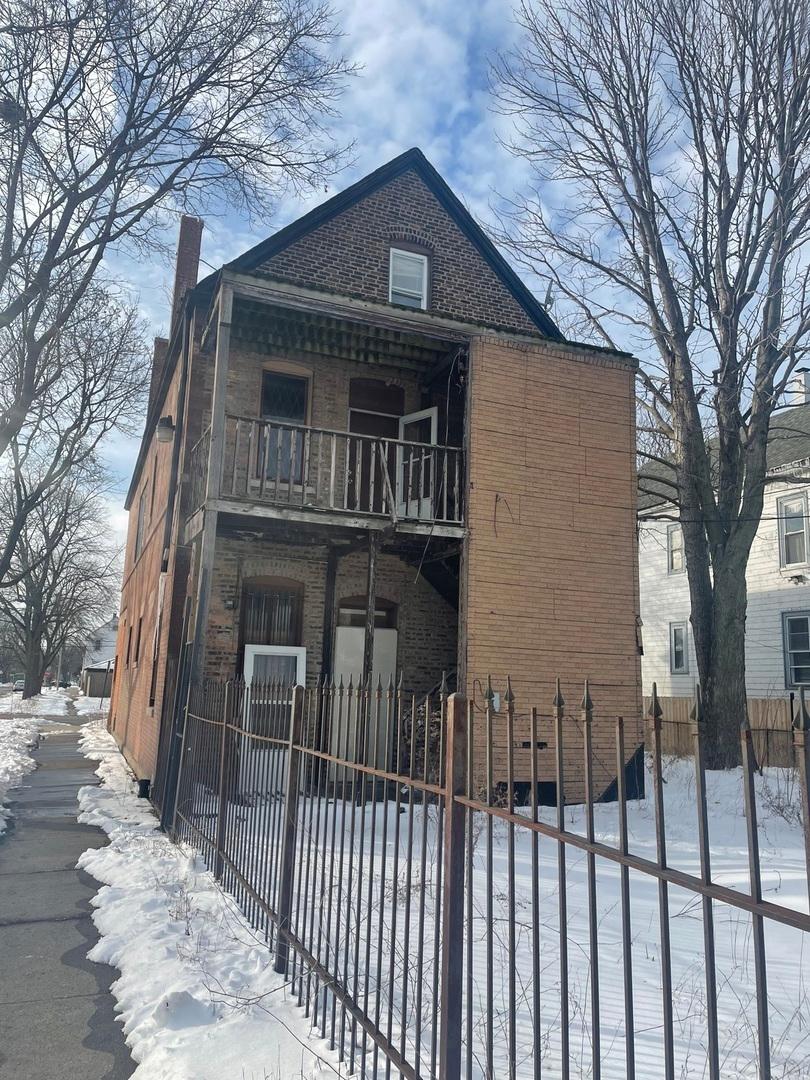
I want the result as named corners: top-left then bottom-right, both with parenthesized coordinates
top-left (638, 404), bottom-right (810, 723)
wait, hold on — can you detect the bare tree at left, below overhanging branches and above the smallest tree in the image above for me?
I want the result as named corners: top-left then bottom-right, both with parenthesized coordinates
top-left (0, 283), bottom-right (149, 590)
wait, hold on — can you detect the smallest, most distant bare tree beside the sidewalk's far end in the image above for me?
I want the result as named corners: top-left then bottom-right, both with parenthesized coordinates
top-left (0, 481), bottom-right (120, 698)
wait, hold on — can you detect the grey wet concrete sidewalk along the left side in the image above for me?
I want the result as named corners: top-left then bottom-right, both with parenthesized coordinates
top-left (0, 706), bottom-right (135, 1080)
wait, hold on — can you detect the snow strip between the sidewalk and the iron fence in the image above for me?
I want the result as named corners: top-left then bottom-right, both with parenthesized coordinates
top-left (79, 717), bottom-right (341, 1080)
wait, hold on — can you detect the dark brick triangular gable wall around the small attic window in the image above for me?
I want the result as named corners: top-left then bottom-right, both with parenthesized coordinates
top-left (262, 172), bottom-right (537, 330)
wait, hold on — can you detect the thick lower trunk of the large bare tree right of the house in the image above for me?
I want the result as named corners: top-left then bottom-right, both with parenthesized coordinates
top-left (698, 554), bottom-right (747, 769)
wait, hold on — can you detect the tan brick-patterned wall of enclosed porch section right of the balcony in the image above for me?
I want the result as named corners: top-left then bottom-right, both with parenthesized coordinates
top-left (464, 339), bottom-right (640, 798)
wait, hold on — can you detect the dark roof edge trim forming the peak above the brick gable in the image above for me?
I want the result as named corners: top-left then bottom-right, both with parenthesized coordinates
top-left (222, 147), bottom-right (564, 341)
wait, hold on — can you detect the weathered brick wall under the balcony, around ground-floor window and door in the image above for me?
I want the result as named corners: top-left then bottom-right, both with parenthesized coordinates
top-left (205, 537), bottom-right (458, 692)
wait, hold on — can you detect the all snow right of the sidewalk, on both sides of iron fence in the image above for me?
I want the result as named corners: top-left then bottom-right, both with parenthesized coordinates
top-left (81, 727), bottom-right (810, 1080)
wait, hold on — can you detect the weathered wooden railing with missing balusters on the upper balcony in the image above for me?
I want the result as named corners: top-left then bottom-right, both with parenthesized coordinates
top-left (191, 416), bottom-right (463, 524)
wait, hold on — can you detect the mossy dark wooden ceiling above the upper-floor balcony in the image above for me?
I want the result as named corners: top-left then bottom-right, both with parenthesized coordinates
top-left (231, 297), bottom-right (461, 373)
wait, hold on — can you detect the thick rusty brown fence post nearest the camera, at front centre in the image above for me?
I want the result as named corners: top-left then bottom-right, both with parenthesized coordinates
top-left (438, 693), bottom-right (472, 1080)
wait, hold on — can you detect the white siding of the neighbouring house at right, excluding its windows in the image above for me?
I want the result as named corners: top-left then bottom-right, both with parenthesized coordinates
top-left (638, 475), bottom-right (810, 698)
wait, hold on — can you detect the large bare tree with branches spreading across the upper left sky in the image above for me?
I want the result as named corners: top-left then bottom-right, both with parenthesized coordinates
top-left (0, 0), bottom-right (350, 455)
